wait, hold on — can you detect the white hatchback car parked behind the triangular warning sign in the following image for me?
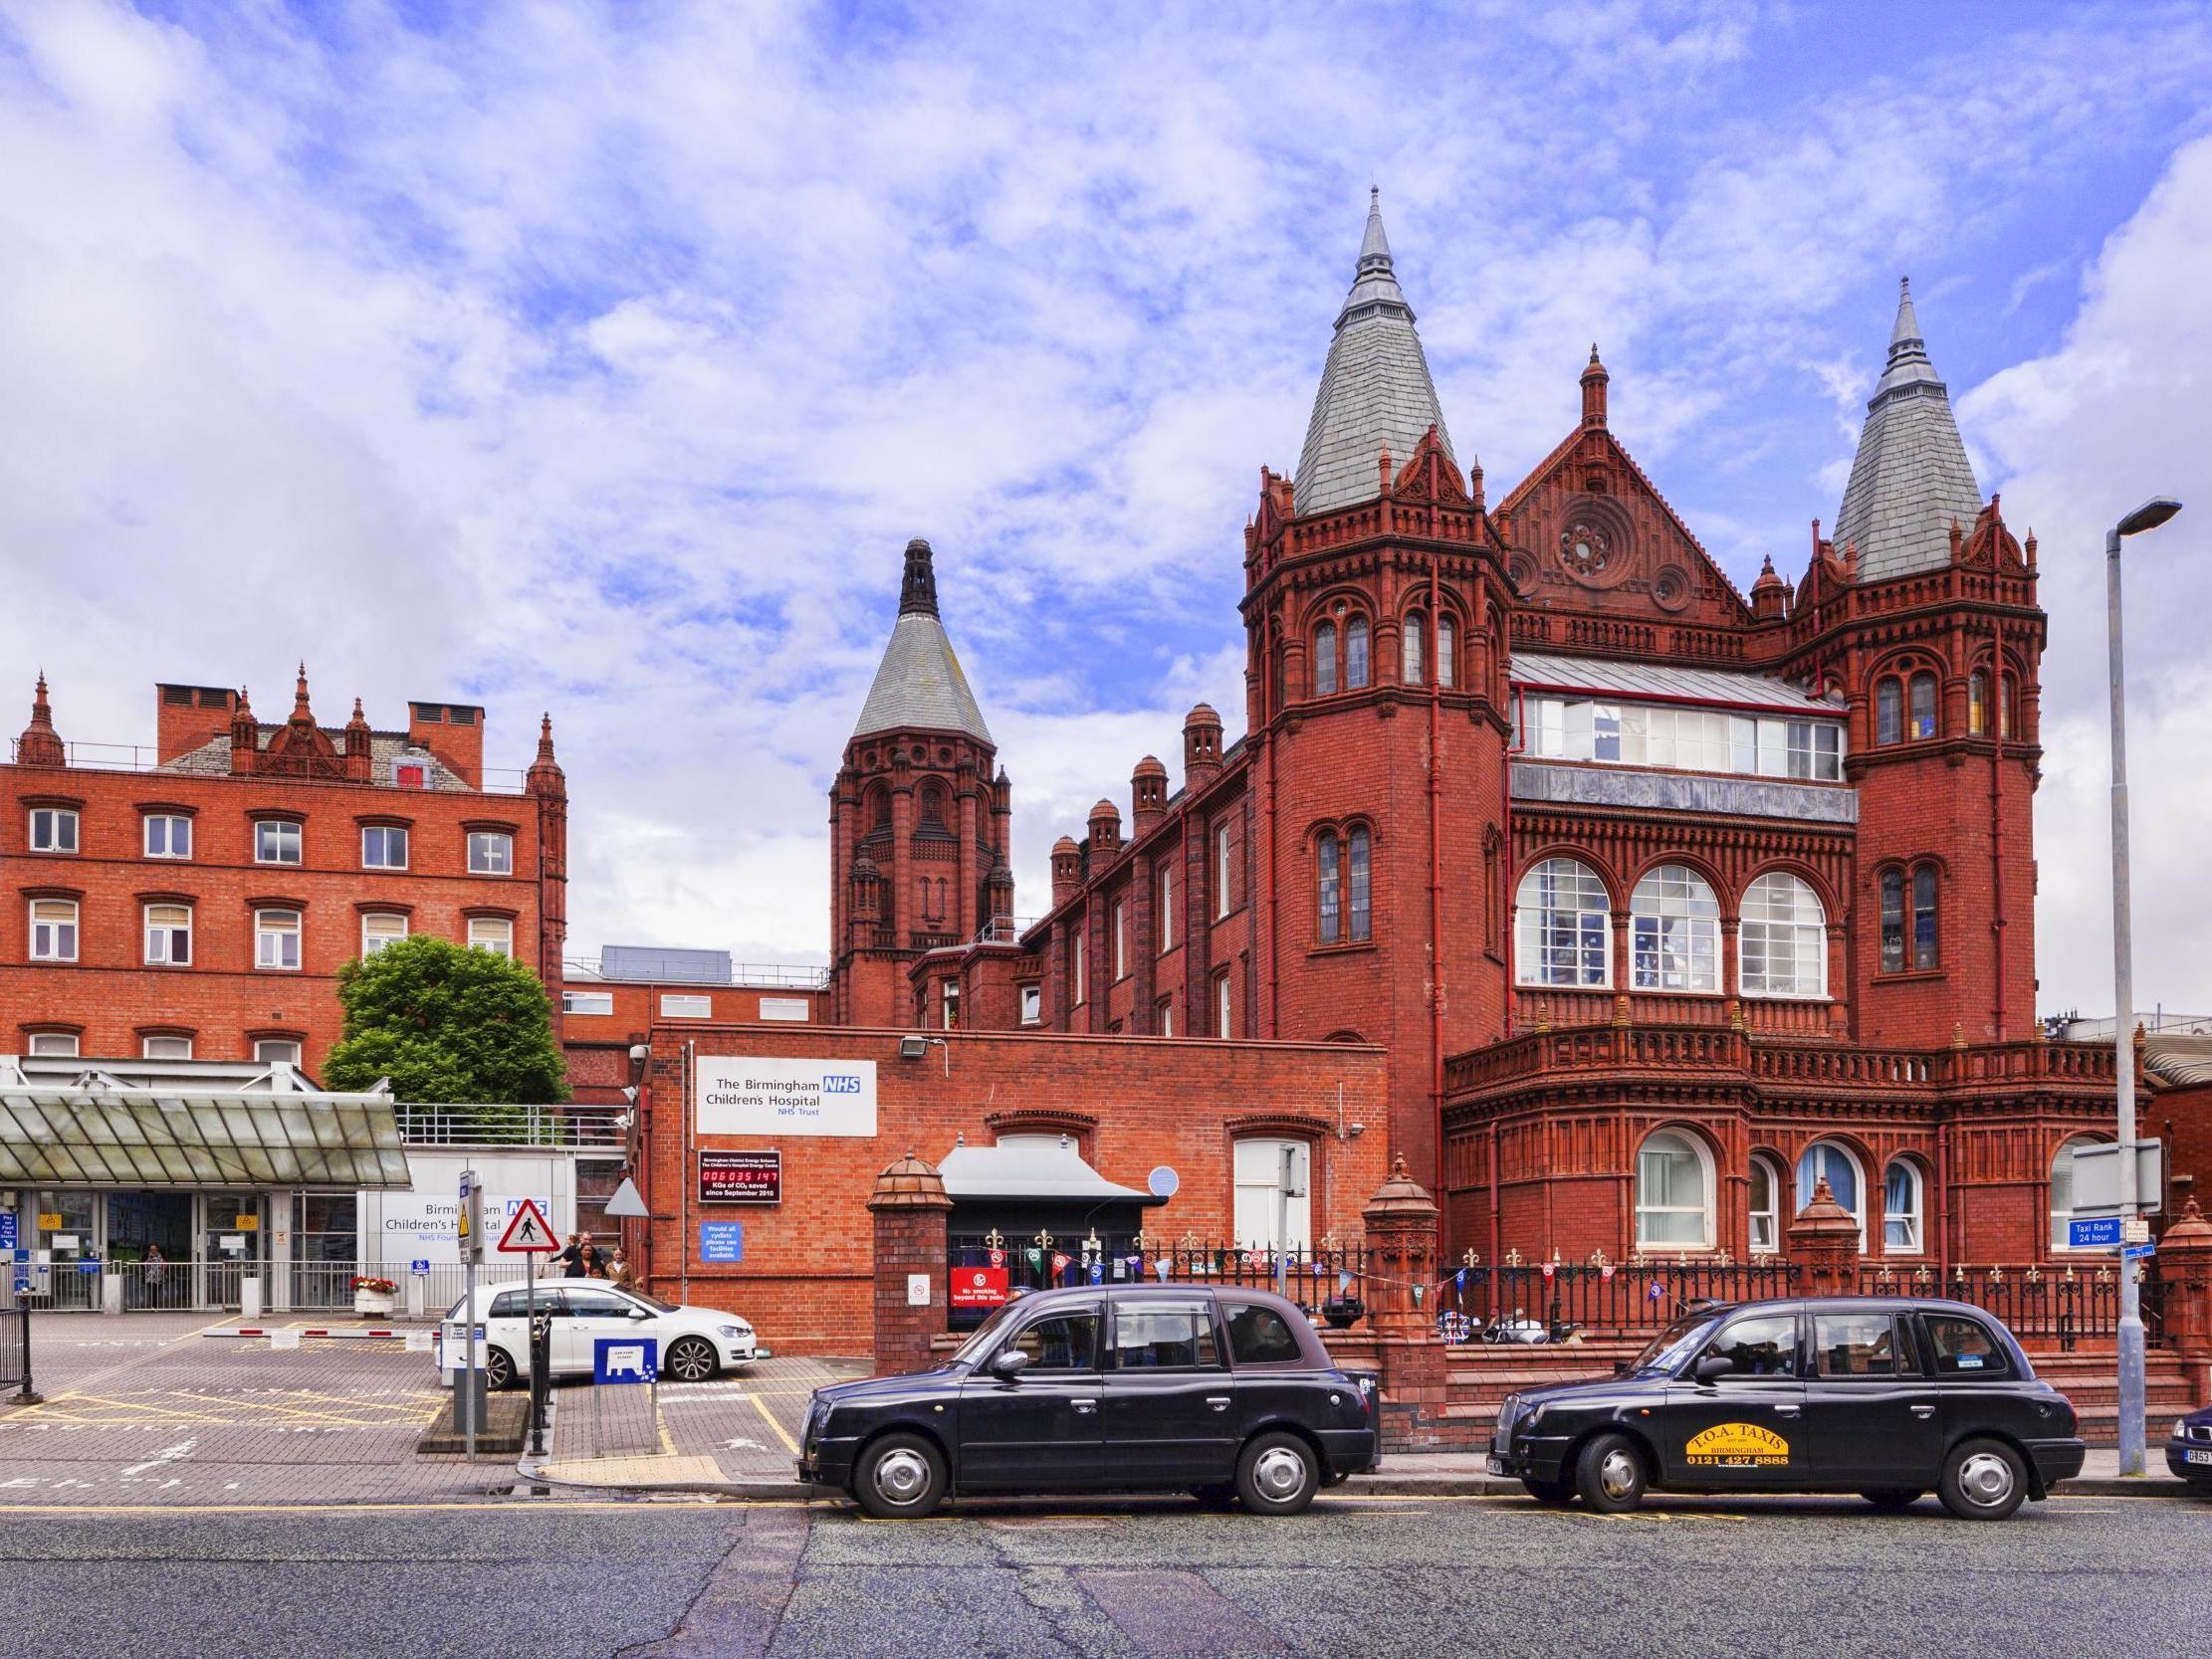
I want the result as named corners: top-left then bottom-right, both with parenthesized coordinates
top-left (438, 1279), bottom-right (764, 1389)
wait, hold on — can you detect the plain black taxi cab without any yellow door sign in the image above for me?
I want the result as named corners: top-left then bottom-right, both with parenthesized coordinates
top-left (798, 1285), bottom-right (1381, 1518)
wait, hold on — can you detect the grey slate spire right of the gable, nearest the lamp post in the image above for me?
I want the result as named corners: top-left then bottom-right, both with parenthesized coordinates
top-left (1834, 277), bottom-right (1982, 582)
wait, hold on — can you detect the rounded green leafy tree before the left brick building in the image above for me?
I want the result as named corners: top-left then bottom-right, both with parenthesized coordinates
top-left (323, 933), bottom-right (568, 1106)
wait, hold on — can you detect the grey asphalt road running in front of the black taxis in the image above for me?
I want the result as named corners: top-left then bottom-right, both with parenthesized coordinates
top-left (0, 1498), bottom-right (2212, 1659)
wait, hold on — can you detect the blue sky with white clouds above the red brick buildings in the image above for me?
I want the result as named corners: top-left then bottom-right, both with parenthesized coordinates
top-left (13, 0), bottom-right (2212, 1011)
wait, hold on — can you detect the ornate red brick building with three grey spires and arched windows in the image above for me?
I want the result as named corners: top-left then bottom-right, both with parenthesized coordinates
top-left (829, 210), bottom-right (2112, 1270)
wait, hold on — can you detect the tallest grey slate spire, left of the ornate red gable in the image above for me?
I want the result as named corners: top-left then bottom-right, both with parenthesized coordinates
top-left (1292, 190), bottom-right (1457, 514)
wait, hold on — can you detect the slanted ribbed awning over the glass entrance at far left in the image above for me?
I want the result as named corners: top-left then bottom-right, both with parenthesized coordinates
top-left (0, 1089), bottom-right (411, 1190)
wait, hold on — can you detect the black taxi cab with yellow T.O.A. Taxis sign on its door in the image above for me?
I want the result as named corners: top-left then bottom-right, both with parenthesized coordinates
top-left (1488, 1296), bottom-right (2084, 1520)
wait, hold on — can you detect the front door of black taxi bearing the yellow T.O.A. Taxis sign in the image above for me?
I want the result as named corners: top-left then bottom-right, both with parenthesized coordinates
top-left (1653, 1308), bottom-right (1812, 1491)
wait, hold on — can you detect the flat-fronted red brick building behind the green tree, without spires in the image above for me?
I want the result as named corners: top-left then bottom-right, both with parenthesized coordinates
top-left (0, 668), bottom-right (568, 1071)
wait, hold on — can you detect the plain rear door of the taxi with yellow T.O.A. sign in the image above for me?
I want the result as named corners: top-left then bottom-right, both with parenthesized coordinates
top-left (1805, 1308), bottom-right (1942, 1489)
